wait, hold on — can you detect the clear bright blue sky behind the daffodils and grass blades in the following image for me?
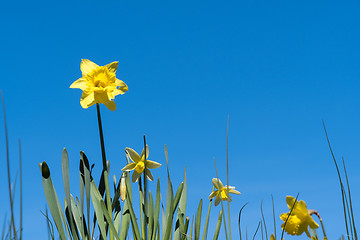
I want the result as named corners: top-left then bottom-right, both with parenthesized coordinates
top-left (0, 0), bottom-right (360, 239)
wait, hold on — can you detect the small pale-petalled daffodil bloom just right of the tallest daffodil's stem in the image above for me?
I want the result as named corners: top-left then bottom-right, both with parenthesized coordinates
top-left (121, 145), bottom-right (161, 182)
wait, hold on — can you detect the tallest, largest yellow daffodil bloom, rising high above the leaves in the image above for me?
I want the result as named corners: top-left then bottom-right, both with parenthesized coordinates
top-left (70, 59), bottom-right (128, 111)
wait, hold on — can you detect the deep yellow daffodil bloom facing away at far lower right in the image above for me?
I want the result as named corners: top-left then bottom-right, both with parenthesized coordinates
top-left (280, 196), bottom-right (319, 238)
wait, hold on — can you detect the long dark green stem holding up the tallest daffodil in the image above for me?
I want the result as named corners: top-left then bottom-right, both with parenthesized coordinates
top-left (96, 103), bottom-right (114, 240)
